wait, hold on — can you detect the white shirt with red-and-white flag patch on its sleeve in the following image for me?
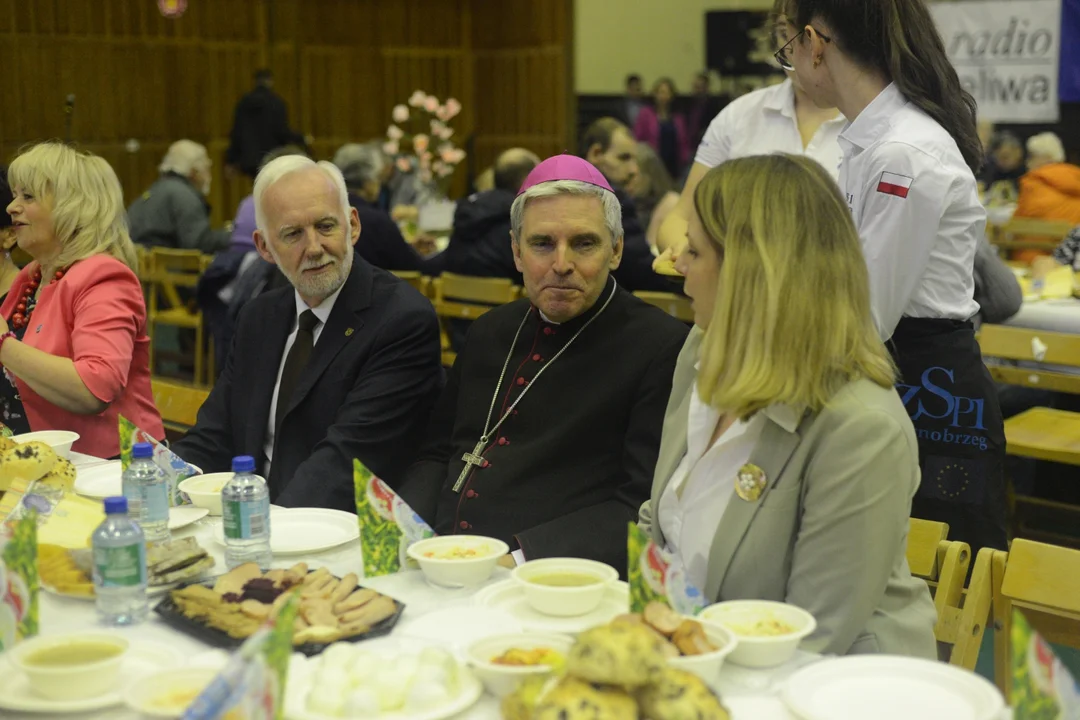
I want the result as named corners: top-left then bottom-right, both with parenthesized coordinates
top-left (839, 84), bottom-right (986, 339)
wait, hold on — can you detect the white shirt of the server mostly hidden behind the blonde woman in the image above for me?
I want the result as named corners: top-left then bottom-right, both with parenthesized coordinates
top-left (694, 79), bottom-right (847, 178)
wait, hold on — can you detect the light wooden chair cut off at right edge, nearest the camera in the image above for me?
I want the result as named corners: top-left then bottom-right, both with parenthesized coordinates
top-left (993, 538), bottom-right (1080, 697)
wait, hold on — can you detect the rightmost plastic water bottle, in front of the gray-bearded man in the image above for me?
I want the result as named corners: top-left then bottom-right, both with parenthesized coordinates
top-left (221, 456), bottom-right (273, 570)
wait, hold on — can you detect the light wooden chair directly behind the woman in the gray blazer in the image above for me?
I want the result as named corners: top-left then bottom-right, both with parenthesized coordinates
top-left (907, 518), bottom-right (991, 670)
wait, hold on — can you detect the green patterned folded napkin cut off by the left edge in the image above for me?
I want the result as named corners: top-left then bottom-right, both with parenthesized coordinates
top-left (0, 510), bottom-right (39, 653)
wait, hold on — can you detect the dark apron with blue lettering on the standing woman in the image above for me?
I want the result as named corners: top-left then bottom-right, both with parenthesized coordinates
top-left (887, 317), bottom-right (1009, 565)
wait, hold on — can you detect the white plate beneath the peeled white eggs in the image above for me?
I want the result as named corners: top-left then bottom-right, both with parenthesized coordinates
top-left (284, 637), bottom-right (484, 720)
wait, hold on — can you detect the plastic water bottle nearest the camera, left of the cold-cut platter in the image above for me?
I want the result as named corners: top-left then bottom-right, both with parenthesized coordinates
top-left (90, 497), bottom-right (147, 625)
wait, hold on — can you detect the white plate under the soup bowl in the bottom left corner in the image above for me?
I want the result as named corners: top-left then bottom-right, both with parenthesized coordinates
top-left (0, 640), bottom-right (184, 715)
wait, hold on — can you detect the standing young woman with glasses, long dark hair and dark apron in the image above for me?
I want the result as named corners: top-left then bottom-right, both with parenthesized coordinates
top-left (777, 0), bottom-right (1007, 552)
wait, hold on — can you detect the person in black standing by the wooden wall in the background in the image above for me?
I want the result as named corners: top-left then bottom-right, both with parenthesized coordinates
top-left (225, 69), bottom-right (307, 178)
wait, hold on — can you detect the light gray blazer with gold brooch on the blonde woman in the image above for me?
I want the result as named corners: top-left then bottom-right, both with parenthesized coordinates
top-left (639, 328), bottom-right (937, 660)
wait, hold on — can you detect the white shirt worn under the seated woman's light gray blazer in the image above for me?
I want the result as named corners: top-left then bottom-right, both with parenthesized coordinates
top-left (657, 388), bottom-right (765, 590)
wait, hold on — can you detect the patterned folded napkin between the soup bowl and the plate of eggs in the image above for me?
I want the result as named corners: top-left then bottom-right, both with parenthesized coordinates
top-left (183, 592), bottom-right (300, 720)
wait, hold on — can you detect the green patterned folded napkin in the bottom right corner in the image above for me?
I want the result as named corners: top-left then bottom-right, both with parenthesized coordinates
top-left (1008, 610), bottom-right (1080, 720)
